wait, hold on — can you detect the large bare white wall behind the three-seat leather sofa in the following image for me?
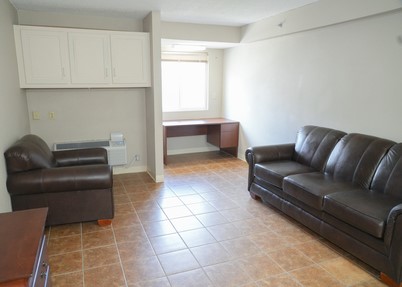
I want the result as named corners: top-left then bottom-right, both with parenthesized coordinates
top-left (223, 7), bottom-right (402, 160)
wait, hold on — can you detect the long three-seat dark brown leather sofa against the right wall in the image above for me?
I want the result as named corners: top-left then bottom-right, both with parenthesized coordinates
top-left (246, 126), bottom-right (402, 286)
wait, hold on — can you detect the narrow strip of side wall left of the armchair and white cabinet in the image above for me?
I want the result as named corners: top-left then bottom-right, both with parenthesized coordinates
top-left (0, 1), bottom-right (29, 212)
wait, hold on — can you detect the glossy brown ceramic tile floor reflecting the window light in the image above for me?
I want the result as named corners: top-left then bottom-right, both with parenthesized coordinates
top-left (47, 152), bottom-right (385, 287)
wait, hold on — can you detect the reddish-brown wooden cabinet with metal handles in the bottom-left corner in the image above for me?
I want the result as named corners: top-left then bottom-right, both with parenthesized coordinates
top-left (0, 208), bottom-right (51, 287)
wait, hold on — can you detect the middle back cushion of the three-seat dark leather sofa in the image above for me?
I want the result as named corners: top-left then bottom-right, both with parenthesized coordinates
top-left (325, 134), bottom-right (395, 189)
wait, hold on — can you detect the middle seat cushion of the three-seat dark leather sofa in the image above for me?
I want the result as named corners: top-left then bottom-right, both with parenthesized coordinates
top-left (283, 172), bottom-right (362, 211)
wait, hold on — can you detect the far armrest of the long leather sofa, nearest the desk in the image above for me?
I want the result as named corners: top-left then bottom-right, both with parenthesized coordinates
top-left (245, 143), bottom-right (295, 190)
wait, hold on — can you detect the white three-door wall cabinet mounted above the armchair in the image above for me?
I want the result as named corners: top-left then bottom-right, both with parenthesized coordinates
top-left (14, 25), bottom-right (151, 88)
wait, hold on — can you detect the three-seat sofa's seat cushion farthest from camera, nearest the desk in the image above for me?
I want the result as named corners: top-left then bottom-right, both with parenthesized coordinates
top-left (254, 160), bottom-right (314, 188)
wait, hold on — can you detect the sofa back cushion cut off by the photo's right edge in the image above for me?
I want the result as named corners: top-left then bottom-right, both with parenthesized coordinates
top-left (371, 143), bottom-right (402, 198)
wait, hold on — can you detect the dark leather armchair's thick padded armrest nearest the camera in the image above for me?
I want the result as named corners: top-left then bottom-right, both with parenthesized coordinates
top-left (7, 164), bottom-right (113, 195)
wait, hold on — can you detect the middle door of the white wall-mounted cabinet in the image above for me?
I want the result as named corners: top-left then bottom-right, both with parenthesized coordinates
top-left (68, 32), bottom-right (112, 86)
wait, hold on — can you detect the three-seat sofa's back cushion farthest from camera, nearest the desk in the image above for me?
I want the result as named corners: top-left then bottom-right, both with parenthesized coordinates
top-left (293, 126), bottom-right (346, 171)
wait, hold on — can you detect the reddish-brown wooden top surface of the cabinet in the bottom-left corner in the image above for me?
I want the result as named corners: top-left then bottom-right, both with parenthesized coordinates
top-left (0, 208), bottom-right (47, 282)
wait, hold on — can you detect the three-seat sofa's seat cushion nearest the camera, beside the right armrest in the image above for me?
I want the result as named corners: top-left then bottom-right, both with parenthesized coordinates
top-left (324, 190), bottom-right (402, 238)
